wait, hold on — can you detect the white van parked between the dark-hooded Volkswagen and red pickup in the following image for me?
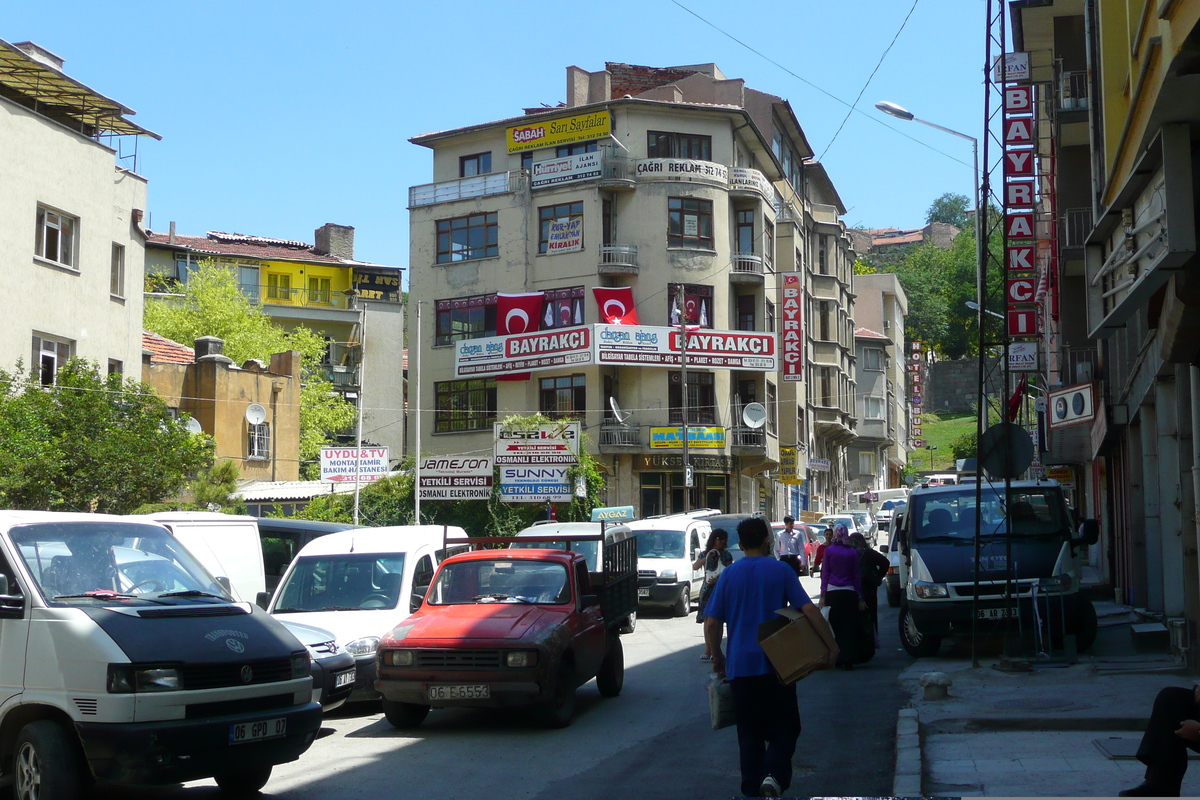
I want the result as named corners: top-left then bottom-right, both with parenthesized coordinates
top-left (268, 525), bottom-right (467, 702)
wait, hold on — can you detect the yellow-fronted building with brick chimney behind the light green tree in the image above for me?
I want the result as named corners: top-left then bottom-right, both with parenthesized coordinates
top-left (145, 223), bottom-right (404, 459)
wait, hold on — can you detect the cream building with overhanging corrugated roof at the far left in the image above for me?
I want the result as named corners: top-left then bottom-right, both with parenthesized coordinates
top-left (0, 40), bottom-right (158, 384)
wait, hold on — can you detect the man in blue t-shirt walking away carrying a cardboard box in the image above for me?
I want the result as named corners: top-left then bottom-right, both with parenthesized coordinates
top-left (704, 517), bottom-right (838, 798)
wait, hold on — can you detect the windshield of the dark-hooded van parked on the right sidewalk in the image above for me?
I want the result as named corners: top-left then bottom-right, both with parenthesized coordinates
top-left (906, 486), bottom-right (1069, 541)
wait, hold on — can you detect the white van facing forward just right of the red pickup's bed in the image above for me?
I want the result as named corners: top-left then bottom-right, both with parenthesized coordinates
top-left (629, 509), bottom-right (719, 616)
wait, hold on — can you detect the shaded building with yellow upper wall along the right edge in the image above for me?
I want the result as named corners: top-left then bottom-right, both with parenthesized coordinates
top-left (1010, 0), bottom-right (1200, 667)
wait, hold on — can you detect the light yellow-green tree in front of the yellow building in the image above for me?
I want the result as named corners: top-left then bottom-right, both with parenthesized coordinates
top-left (143, 259), bottom-right (356, 477)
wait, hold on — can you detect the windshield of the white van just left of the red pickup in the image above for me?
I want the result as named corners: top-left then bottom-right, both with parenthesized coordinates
top-left (274, 553), bottom-right (404, 613)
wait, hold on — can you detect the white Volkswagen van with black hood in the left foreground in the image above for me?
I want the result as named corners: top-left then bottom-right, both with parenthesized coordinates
top-left (0, 511), bottom-right (320, 800)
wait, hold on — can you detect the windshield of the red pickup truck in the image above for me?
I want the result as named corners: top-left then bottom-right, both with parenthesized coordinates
top-left (426, 559), bottom-right (571, 606)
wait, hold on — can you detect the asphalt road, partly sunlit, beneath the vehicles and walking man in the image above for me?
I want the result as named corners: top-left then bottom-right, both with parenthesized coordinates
top-left (110, 579), bottom-right (910, 800)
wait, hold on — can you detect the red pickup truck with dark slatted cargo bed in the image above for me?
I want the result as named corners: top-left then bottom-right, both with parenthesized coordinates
top-left (376, 535), bottom-right (637, 728)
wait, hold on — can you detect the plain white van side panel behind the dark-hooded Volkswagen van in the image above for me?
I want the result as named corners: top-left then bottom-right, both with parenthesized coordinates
top-left (137, 511), bottom-right (266, 603)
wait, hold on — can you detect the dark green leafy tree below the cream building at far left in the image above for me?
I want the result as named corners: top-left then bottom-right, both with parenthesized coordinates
top-left (0, 360), bottom-right (212, 513)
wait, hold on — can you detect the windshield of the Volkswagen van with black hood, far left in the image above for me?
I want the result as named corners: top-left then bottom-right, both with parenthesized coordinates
top-left (10, 522), bottom-right (233, 606)
